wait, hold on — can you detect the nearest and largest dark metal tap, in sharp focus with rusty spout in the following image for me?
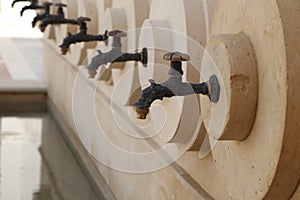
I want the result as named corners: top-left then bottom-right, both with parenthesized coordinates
top-left (134, 52), bottom-right (220, 119)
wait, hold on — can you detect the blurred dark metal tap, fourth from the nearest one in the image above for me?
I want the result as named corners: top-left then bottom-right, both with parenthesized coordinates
top-left (39, 3), bottom-right (78, 32)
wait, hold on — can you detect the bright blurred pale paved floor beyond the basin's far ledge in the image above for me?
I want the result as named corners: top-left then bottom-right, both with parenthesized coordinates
top-left (0, 0), bottom-right (43, 80)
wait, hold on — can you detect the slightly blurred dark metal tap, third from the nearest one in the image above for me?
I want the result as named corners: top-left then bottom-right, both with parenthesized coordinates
top-left (59, 17), bottom-right (108, 55)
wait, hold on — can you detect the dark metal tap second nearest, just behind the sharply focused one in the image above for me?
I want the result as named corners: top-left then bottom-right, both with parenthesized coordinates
top-left (87, 30), bottom-right (148, 78)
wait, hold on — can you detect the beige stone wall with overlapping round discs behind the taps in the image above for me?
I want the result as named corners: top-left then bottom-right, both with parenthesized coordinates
top-left (44, 0), bottom-right (300, 199)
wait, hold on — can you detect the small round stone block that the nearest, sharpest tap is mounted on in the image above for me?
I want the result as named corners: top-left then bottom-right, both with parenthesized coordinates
top-left (201, 33), bottom-right (257, 141)
